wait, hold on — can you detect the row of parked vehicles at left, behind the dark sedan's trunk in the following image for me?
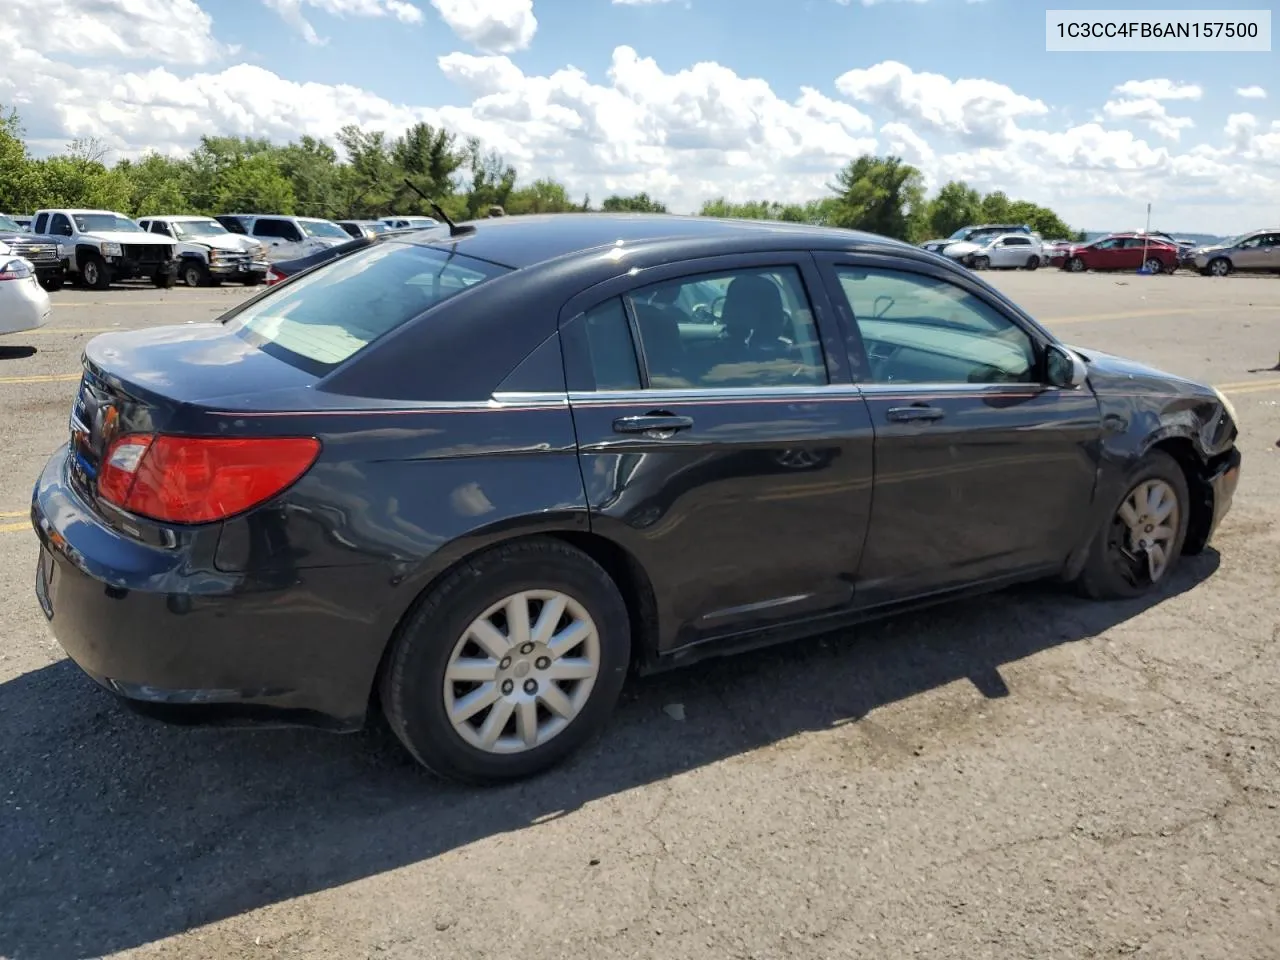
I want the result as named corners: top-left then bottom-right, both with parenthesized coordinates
top-left (0, 209), bottom-right (438, 291)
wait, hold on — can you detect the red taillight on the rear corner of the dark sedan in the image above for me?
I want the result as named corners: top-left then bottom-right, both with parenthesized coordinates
top-left (97, 434), bottom-right (320, 524)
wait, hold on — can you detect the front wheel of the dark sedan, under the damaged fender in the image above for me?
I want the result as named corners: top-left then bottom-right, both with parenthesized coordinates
top-left (1079, 451), bottom-right (1190, 599)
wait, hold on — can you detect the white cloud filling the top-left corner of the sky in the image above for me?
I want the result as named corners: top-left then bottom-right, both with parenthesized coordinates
top-left (0, 0), bottom-right (230, 67)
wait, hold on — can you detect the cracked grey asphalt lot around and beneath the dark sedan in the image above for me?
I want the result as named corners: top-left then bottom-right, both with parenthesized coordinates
top-left (0, 271), bottom-right (1280, 960)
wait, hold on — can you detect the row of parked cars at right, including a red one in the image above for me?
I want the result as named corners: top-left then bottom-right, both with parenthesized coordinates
top-left (920, 224), bottom-right (1280, 276)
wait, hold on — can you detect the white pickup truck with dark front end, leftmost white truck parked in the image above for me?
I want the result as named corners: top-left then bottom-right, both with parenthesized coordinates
top-left (32, 210), bottom-right (178, 291)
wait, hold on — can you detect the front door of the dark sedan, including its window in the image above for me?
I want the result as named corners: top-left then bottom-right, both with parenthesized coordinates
top-left (823, 255), bottom-right (1101, 607)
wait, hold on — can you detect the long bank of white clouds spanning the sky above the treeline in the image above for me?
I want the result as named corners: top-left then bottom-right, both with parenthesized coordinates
top-left (0, 8), bottom-right (1280, 233)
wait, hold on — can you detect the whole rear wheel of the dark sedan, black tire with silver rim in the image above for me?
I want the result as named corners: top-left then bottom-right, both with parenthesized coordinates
top-left (380, 538), bottom-right (631, 783)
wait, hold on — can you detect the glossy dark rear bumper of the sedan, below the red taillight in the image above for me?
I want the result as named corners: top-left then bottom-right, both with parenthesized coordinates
top-left (31, 447), bottom-right (385, 730)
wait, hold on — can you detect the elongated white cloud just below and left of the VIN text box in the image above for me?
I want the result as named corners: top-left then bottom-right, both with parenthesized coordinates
top-left (836, 60), bottom-right (1048, 147)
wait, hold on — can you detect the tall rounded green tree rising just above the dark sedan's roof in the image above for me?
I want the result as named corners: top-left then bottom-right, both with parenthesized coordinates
top-left (831, 154), bottom-right (924, 239)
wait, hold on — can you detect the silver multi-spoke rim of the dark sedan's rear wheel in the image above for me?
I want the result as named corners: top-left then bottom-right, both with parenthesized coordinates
top-left (444, 590), bottom-right (600, 754)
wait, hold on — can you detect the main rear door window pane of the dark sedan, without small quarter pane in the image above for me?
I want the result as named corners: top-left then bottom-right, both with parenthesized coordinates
top-left (628, 266), bottom-right (828, 389)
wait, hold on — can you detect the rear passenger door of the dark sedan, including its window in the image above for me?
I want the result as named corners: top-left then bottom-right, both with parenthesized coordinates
top-left (562, 253), bottom-right (873, 649)
